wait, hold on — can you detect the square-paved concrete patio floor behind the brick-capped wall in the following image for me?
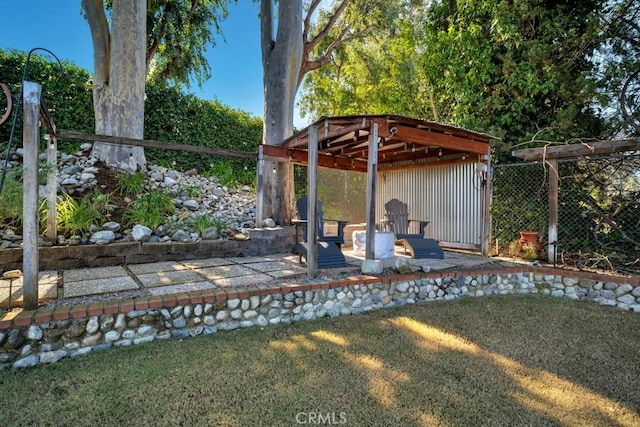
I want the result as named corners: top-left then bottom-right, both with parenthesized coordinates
top-left (0, 247), bottom-right (503, 309)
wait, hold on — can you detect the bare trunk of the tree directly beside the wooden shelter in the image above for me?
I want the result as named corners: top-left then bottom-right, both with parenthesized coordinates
top-left (260, 0), bottom-right (303, 225)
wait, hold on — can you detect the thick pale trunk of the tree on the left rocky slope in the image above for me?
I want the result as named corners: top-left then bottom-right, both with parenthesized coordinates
top-left (83, 0), bottom-right (147, 171)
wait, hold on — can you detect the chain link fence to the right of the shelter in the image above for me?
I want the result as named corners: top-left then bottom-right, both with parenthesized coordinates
top-left (491, 153), bottom-right (640, 274)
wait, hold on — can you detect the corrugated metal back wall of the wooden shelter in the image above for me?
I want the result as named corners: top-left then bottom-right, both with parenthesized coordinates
top-left (376, 163), bottom-right (483, 249)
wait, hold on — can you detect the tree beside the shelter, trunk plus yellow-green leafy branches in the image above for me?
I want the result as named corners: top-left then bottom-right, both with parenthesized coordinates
top-left (260, 0), bottom-right (395, 224)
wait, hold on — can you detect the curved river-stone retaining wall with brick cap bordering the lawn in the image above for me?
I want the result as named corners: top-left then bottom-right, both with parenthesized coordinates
top-left (0, 267), bottom-right (640, 370)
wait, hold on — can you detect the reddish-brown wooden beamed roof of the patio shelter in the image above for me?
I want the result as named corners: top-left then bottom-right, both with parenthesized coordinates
top-left (263, 115), bottom-right (498, 172)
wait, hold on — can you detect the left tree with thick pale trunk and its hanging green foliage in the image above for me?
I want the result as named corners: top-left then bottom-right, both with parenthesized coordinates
top-left (82, 0), bottom-right (232, 170)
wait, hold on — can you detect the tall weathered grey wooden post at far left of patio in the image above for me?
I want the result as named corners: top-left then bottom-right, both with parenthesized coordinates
top-left (22, 81), bottom-right (41, 310)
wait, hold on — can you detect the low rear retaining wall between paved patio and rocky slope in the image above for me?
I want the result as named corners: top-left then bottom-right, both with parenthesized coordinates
top-left (0, 226), bottom-right (295, 270)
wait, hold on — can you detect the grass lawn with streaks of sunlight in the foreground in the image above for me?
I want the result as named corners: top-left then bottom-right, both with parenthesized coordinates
top-left (0, 296), bottom-right (640, 426)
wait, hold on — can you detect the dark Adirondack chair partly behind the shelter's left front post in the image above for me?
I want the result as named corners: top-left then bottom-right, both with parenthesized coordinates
top-left (293, 196), bottom-right (349, 268)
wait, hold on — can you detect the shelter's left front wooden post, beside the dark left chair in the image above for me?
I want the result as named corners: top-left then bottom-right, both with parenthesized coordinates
top-left (307, 125), bottom-right (322, 277)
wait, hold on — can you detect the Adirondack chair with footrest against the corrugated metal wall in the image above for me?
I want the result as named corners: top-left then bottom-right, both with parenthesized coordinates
top-left (383, 199), bottom-right (444, 259)
